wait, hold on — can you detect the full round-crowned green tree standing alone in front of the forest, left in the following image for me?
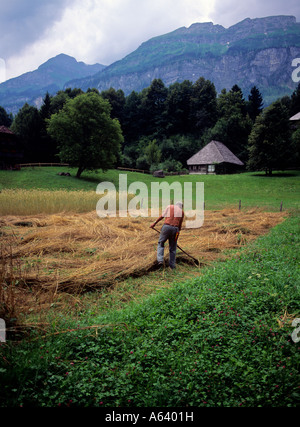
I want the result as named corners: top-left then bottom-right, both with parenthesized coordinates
top-left (48, 92), bottom-right (123, 178)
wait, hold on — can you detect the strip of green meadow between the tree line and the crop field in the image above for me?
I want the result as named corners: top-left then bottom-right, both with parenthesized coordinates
top-left (0, 167), bottom-right (300, 215)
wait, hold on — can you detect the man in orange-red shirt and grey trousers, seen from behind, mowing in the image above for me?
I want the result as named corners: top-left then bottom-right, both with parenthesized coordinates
top-left (150, 202), bottom-right (184, 270)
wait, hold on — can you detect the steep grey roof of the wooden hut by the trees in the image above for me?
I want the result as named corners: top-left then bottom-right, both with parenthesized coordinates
top-left (187, 141), bottom-right (244, 166)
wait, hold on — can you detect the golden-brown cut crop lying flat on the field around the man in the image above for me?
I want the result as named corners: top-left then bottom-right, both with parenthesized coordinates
top-left (0, 209), bottom-right (284, 293)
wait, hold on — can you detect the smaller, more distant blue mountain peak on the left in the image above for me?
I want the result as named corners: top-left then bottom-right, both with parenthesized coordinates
top-left (0, 54), bottom-right (105, 114)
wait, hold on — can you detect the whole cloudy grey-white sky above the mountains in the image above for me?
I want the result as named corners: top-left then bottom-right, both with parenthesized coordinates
top-left (0, 0), bottom-right (300, 81)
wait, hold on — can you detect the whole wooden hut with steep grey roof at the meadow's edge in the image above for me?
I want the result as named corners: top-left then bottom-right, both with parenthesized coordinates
top-left (187, 141), bottom-right (244, 175)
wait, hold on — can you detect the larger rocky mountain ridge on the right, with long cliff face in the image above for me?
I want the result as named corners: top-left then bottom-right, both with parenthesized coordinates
top-left (65, 16), bottom-right (300, 104)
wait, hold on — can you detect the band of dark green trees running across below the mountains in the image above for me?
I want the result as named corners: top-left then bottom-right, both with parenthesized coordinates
top-left (0, 77), bottom-right (300, 176)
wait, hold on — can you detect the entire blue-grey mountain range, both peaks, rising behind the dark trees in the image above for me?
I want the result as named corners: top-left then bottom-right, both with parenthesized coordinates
top-left (0, 16), bottom-right (300, 114)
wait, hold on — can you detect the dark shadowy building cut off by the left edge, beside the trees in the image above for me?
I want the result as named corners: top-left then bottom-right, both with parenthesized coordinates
top-left (0, 126), bottom-right (24, 169)
